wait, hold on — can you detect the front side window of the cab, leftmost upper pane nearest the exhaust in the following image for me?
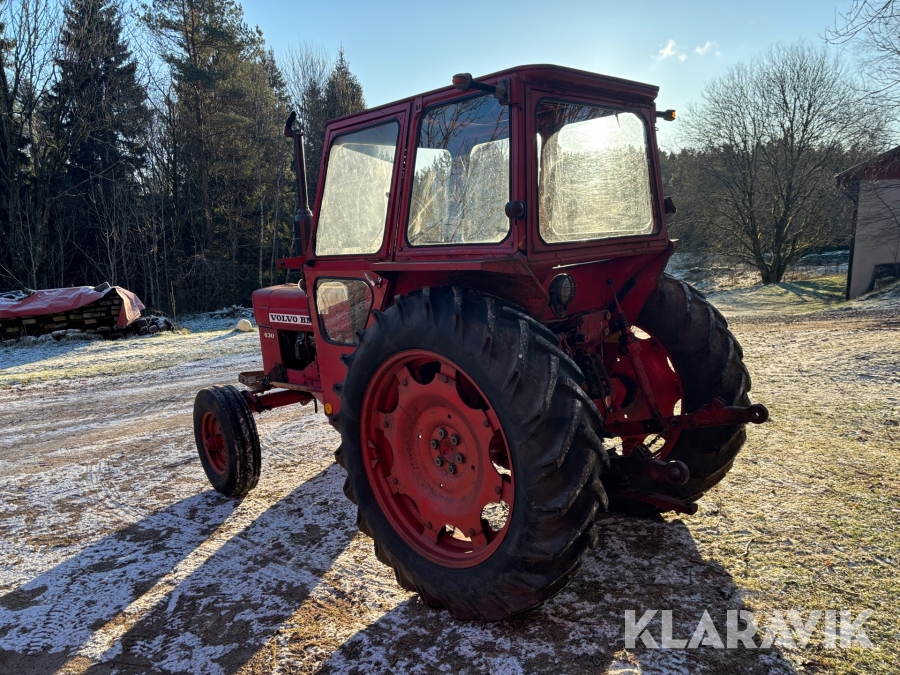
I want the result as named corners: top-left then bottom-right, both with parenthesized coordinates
top-left (316, 122), bottom-right (400, 256)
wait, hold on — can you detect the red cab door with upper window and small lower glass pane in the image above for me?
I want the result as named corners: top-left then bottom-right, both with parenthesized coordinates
top-left (304, 103), bottom-right (409, 416)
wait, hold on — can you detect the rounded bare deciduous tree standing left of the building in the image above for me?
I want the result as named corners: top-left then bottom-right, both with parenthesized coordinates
top-left (683, 42), bottom-right (887, 284)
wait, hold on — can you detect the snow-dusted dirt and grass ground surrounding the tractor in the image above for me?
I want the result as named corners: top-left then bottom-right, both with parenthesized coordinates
top-left (0, 312), bottom-right (900, 673)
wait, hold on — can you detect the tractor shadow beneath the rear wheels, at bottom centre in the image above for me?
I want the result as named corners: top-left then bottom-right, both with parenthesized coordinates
top-left (318, 515), bottom-right (795, 675)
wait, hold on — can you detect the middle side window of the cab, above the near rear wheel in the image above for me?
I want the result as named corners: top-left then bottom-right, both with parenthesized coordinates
top-left (407, 95), bottom-right (509, 246)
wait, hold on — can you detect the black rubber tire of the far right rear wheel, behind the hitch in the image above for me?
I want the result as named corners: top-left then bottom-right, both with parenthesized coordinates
top-left (610, 275), bottom-right (750, 515)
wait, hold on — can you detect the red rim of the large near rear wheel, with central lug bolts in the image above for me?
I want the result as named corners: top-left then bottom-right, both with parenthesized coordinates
top-left (360, 350), bottom-right (514, 568)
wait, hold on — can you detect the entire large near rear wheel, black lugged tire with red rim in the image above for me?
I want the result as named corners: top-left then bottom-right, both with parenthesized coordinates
top-left (336, 288), bottom-right (608, 621)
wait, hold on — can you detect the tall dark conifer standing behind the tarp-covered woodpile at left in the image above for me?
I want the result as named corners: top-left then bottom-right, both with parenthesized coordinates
top-left (48, 0), bottom-right (150, 283)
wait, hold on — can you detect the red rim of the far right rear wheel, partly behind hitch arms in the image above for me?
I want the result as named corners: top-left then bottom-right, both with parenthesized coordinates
top-left (609, 328), bottom-right (684, 459)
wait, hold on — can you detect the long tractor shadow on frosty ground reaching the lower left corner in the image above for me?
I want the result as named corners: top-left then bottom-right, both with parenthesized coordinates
top-left (0, 465), bottom-right (357, 674)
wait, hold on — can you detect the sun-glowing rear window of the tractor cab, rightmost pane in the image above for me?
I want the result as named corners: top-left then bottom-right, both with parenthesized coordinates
top-left (537, 101), bottom-right (653, 243)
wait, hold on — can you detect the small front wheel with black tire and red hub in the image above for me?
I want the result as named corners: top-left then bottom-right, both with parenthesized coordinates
top-left (194, 385), bottom-right (261, 497)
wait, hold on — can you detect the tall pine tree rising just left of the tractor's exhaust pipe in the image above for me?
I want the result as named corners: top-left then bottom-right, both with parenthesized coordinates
top-left (146, 0), bottom-right (290, 307)
